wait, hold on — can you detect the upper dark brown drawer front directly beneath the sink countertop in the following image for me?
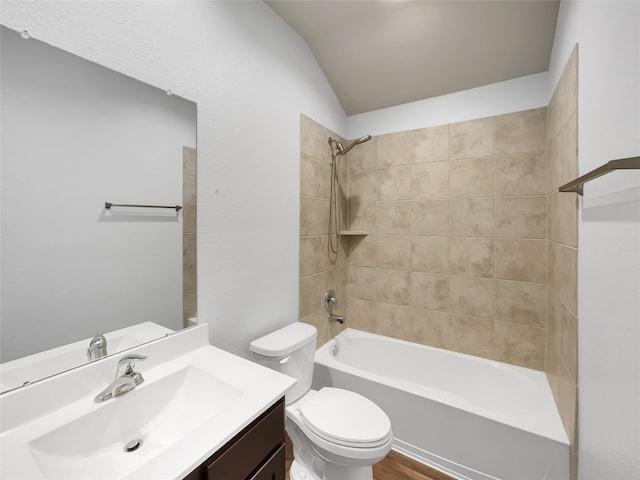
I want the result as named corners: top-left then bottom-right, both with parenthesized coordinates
top-left (206, 401), bottom-right (284, 480)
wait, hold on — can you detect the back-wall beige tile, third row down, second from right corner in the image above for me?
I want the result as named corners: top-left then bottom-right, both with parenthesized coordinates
top-left (451, 198), bottom-right (494, 237)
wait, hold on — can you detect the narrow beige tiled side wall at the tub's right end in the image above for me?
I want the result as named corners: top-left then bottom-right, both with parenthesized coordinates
top-left (545, 46), bottom-right (578, 468)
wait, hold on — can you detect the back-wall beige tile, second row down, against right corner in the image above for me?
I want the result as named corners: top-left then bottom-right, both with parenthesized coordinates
top-left (495, 150), bottom-right (547, 195)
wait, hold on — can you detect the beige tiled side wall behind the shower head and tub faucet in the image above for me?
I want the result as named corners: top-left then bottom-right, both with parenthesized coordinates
top-left (298, 115), bottom-right (347, 346)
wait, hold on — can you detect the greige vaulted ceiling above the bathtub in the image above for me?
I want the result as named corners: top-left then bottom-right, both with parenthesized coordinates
top-left (266, 0), bottom-right (559, 115)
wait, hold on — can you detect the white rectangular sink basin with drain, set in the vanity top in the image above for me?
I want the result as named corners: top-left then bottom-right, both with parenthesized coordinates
top-left (28, 366), bottom-right (242, 479)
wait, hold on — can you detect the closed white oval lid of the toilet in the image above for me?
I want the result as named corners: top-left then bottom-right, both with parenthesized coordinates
top-left (300, 387), bottom-right (391, 447)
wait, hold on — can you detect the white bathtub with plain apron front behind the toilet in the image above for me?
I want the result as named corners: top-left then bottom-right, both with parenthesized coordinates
top-left (313, 328), bottom-right (569, 480)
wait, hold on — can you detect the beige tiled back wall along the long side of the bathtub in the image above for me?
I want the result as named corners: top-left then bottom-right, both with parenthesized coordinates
top-left (347, 108), bottom-right (547, 370)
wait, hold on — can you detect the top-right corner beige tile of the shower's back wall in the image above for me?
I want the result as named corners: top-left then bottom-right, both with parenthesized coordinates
top-left (495, 107), bottom-right (547, 155)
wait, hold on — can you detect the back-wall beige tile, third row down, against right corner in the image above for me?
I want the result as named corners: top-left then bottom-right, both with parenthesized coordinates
top-left (495, 196), bottom-right (547, 238)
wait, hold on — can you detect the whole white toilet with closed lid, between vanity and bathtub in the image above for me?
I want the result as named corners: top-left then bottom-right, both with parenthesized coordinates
top-left (249, 322), bottom-right (393, 480)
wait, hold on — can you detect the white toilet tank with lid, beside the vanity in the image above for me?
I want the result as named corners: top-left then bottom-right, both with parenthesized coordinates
top-left (249, 322), bottom-right (318, 405)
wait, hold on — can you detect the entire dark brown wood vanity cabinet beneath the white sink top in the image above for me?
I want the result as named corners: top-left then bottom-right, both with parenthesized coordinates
top-left (185, 398), bottom-right (285, 480)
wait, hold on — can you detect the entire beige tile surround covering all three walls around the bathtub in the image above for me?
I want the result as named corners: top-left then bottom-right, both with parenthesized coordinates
top-left (300, 47), bottom-right (578, 462)
